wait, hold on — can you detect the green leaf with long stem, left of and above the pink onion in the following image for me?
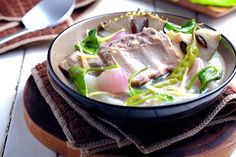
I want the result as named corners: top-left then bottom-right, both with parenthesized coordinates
top-left (69, 65), bottom-right (119, 96)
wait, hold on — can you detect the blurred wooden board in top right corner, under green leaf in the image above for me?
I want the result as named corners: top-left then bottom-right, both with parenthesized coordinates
top-left (168, 0), bottom-right (236, 17)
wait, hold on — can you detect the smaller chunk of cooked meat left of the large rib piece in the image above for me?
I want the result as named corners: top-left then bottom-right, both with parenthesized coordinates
top-left (59, 51), bottom-right (104, 71)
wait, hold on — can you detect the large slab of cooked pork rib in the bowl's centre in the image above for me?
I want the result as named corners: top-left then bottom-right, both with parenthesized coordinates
top-left (98, 28), bottom-right (183, 86)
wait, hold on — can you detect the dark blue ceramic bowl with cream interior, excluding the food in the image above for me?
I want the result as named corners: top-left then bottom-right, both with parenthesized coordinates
top-left (47, 13), bottom-right (236, 121)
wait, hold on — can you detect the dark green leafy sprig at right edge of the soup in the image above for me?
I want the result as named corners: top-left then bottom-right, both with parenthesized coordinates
top-left (187, 66), bottom-right (223, 93)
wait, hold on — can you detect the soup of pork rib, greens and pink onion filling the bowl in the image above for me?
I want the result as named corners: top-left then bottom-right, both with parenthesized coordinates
top-left (59, 11), bottom-right (224, 106)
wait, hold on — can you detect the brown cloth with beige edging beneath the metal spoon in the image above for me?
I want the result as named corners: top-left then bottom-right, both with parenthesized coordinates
top-left (0, 0), bottom-right (95, 54)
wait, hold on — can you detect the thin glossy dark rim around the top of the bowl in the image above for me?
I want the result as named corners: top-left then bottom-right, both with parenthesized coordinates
top-left (47, 11), bottom-right (236, 110)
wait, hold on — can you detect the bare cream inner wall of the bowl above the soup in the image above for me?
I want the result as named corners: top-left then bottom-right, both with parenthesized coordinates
top-left (50, 13), bottom-right (236, 94)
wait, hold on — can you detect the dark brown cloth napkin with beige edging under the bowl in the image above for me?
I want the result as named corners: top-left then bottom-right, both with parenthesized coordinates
top-left (32, 61), bottom-right (236, 155)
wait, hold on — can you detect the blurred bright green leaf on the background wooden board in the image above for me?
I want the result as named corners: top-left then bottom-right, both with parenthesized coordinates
top-left (191, 0), bottom-right (236, 7)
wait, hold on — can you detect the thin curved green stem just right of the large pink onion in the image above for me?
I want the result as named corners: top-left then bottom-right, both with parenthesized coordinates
top-left (128, 67), bottom-right (148, 96)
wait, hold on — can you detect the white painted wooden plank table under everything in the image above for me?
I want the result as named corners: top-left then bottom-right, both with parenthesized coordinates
top-left (0, 0), bottom-right (236, 157)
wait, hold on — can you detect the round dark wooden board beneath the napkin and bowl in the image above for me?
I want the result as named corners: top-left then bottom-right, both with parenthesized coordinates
top-left (24, 76), bottom-right (236, 157)
